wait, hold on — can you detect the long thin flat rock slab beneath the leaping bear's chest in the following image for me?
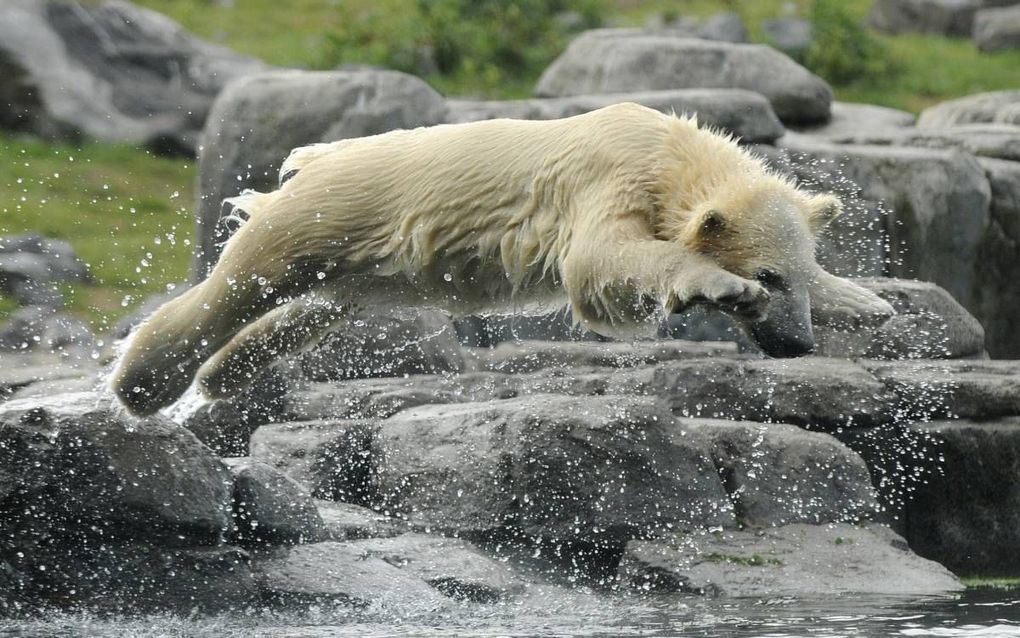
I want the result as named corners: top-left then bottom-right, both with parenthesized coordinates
top-left (471, 341), bottom-right (736, 374)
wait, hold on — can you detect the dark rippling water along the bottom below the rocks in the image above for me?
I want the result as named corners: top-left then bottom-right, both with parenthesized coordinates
top-left (0, 588), bottom-right (1020, 638)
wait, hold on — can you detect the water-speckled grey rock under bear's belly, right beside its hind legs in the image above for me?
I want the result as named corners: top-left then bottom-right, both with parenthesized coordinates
top-left (301, 308), bottom-right (464, 381)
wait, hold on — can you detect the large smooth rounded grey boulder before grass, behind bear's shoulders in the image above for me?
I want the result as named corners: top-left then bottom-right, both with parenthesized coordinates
top-left (536, 29), bottom-right (832, 124)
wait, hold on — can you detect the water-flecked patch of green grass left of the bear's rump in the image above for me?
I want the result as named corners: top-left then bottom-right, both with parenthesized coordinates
top-left (0, 136), bottom-right (195, 328)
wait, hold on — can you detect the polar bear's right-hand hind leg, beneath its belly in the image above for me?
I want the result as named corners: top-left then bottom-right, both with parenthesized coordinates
top-left (198, 296), bottom-right (347, 399)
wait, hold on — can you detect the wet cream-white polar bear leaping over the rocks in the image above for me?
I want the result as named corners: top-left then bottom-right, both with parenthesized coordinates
top-left (111, 103), bottom-right (893, 414)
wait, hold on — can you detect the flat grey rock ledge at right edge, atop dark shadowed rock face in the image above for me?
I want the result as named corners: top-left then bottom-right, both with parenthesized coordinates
top-left (862, 359), bottom-right (1020, 422)
